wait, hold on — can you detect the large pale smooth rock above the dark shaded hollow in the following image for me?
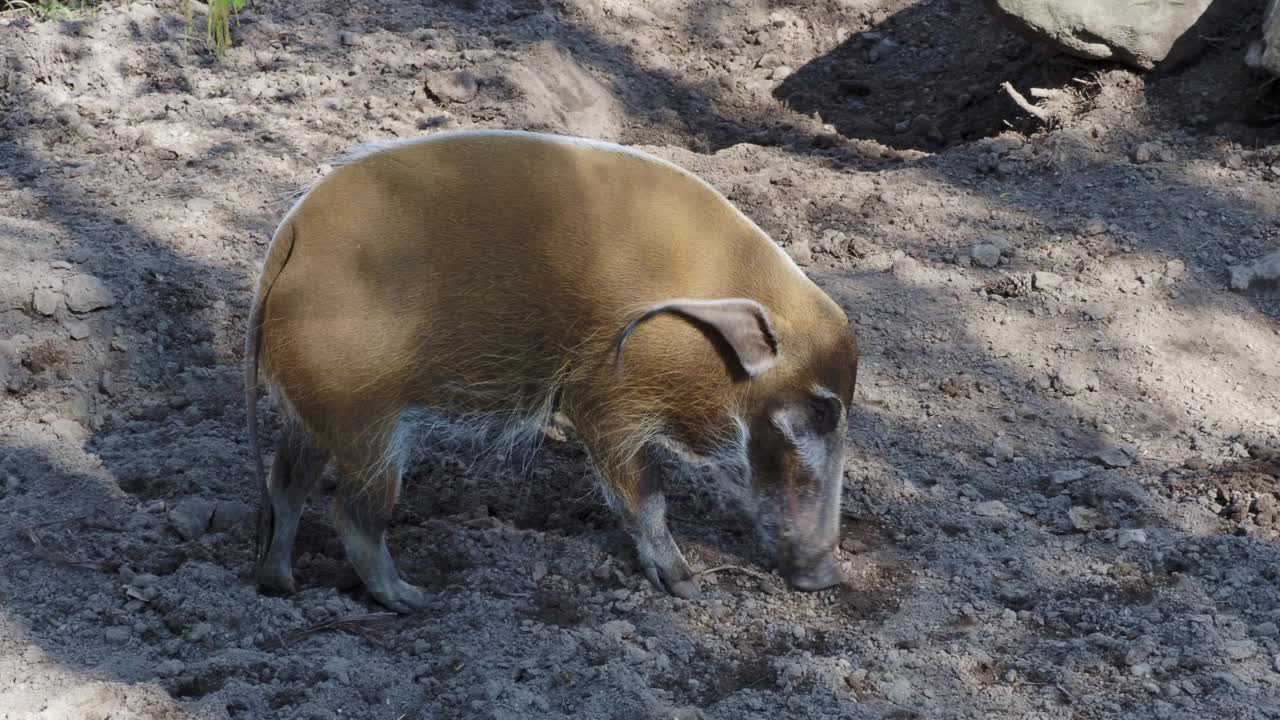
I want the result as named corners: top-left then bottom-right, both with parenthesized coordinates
top-left (986, 0), bottom-right (1212, 70)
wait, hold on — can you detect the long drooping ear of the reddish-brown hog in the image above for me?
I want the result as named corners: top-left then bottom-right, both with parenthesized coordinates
top-left (614, 297), bottom-right (778, 378)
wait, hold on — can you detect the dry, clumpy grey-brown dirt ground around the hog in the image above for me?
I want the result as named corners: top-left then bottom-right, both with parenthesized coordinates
top-left (0, 0), bottom-right (1280, 720)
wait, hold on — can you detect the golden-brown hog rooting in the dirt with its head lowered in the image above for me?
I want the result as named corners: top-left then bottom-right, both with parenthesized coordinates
top-left (247, 131), bottom-right (856, 610)
